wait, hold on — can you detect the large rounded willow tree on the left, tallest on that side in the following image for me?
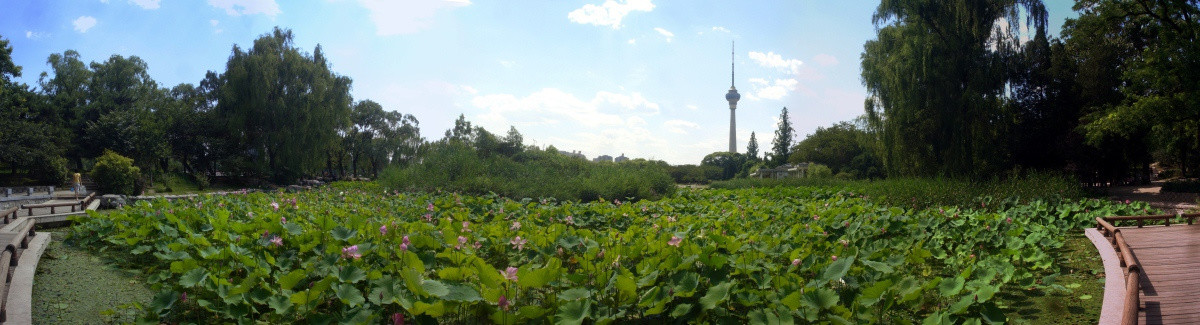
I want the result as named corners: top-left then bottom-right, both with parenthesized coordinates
top-left (215, 28), bottom-right (352, 181)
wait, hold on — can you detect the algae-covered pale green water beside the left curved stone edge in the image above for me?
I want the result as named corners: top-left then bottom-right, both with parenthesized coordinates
top-left (32, 228), bottom-right (154, 324)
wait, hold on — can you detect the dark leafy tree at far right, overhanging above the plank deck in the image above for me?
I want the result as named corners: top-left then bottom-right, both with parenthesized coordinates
top-left (1063, 0), bottom-right (1200, 175)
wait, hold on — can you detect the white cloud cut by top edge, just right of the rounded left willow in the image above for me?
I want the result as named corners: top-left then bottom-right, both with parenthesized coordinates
top-left (359, 0), bottom-right (470, 36)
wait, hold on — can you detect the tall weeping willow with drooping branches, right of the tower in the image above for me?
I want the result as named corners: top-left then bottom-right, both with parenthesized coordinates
top-left (862, 0), bottom-right (1046, 176)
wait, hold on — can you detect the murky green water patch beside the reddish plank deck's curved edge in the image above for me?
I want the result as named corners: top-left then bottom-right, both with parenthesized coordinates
top-left (996, 231), bottom-right (1104, 324)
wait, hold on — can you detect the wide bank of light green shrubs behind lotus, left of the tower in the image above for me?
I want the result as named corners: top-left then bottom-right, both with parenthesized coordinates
top-left (379, 140), bottom-right (674, 201)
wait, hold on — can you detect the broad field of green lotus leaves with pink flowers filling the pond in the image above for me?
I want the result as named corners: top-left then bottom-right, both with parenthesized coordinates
top-left (71, 183), bottom-right (1147, 324)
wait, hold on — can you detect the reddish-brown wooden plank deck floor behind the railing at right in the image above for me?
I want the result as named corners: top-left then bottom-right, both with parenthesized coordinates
top-left (1120, 224), bottom-right (1200, 324)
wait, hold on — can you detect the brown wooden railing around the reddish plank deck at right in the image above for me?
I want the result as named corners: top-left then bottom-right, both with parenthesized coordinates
top-left (1096, 213), bottom-right (1200, 325)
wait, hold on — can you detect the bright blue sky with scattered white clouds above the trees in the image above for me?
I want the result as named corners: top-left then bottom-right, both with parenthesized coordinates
top-left (0, 0), bottom-right (1076, 164)
